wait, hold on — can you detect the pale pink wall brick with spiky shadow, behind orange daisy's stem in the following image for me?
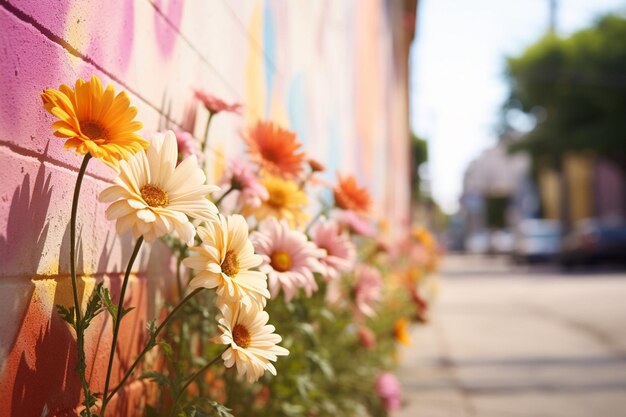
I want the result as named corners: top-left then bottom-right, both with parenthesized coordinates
top-left (0, 146), bottom-right (154, 277)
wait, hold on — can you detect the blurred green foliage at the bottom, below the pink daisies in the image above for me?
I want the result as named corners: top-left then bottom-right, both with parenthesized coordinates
top-left (216, 276), bottom-right (410, 417)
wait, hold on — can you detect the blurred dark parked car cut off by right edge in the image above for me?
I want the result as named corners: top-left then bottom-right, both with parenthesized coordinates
top-left (560, 219), bottom-right (626, 266)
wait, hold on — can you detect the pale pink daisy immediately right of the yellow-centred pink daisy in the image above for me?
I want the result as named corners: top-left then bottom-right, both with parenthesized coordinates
top-left (311, 219), bottom-right (356, 280)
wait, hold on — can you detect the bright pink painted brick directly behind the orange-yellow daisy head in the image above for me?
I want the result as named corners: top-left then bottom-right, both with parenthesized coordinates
top-left (0, 8), bottom-right (159, 178)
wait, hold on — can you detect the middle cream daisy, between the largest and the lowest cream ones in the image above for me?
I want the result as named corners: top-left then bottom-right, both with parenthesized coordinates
top-left (183, 214), bottom-right (270, 307)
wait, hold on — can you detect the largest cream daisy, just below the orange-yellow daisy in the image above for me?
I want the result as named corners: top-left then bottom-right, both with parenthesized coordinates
top-left (100, 131), bottom-right (219, 245)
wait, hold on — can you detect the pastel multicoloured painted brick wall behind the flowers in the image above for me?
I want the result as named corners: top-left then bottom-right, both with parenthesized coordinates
top-left (0, 0), bottom-right (414, 417)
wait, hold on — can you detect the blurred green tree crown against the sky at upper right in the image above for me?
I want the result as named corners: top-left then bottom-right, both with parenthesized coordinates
top-left (505, 15), bottom-right (626, 168)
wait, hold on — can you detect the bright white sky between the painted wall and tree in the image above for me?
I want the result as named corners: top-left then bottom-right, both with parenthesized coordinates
top-left (411, 0), bottom-right (626, 214)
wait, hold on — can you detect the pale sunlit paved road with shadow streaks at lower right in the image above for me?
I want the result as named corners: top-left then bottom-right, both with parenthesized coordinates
top-left (394, 256), bottom-right (626, 417)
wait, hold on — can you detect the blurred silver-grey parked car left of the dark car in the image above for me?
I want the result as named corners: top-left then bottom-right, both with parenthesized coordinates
top-left (513, 219), bottom-right (561, 262)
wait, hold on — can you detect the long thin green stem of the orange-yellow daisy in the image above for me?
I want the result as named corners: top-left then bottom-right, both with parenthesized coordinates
top-left (70, 153), bottom-right (91, 416)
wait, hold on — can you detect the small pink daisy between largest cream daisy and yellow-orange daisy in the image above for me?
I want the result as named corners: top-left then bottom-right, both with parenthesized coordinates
top-left (220, 159), bottom-right (269, 207)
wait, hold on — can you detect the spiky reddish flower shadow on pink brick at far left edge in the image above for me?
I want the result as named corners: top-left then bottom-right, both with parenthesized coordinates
top-left (0, 145), bottom-right (53, 276)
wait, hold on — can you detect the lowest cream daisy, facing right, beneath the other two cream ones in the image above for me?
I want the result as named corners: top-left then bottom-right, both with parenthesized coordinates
top-left (216, 303), bottom-right (289, 383)
